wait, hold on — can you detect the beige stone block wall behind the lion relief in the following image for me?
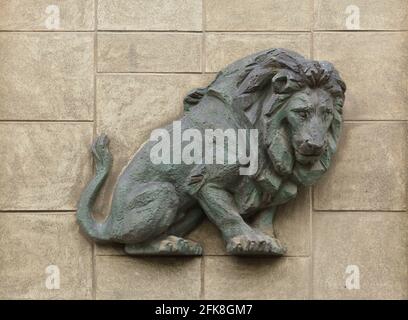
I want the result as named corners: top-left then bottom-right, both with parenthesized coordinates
top-left (0, 0), bottom-right (408, 299)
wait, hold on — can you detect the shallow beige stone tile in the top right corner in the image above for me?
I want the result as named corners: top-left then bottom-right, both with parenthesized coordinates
top-left (315, 0), bottom-right (408, 30)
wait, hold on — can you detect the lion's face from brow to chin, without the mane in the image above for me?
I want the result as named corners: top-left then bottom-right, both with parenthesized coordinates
top-left (285, 88), bottom-right (334, 164)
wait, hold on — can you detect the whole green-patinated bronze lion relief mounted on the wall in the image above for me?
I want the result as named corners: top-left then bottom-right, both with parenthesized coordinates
top-left (77, 48), bottom-right (346, 256)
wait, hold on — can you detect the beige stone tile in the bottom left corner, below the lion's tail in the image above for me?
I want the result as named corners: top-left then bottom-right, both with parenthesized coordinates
top-left (0, 212), bottom-right (92, 299)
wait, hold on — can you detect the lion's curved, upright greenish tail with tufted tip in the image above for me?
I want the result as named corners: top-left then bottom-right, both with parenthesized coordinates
top-left (77, 134), bottom-right (112, 242)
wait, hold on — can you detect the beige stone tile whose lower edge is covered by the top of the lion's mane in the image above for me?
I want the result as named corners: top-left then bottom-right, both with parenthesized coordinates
top-left (206, 33), bottom-right (310, 72)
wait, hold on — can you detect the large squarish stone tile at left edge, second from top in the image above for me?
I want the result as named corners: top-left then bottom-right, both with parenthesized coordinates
top-left (0, 32), bottom-right (94, 120)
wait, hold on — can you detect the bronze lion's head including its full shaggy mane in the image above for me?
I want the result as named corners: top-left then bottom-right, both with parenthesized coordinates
top-left (185, 49), bottom-right (346, 185)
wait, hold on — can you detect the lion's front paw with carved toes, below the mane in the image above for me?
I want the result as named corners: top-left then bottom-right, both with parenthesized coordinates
top-left (227, 235), bottom-right (286, 256)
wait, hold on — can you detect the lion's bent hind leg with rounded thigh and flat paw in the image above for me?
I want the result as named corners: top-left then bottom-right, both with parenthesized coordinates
top-left (121, 182), bottom-right (202, 255)
